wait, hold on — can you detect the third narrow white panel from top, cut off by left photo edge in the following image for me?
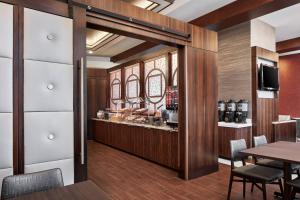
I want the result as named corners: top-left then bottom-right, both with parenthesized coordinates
top-left (0, 113), bottom-right (13, 169)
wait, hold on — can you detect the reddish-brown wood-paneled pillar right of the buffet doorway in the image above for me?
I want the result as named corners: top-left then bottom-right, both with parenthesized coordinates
top-left (181, 47), bottom-right (218, 179)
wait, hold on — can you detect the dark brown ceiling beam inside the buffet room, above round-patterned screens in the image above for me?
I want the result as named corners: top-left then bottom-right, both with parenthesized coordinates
top-left (110, 42), bottom-right (158, 62)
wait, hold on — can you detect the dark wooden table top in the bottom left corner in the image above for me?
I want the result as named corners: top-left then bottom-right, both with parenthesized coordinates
top-left (13, 181), bottom-right (111, 200)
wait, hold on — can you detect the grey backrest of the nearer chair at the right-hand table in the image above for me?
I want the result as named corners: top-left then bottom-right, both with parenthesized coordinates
top-left (230, 139), bottom-right (248, 168)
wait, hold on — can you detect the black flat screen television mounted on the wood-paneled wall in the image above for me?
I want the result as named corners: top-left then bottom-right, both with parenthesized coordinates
top-left (259, 64), bottom-right (279, 91)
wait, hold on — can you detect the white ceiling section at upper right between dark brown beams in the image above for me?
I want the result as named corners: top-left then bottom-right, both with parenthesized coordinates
top-left (259, 4), bottom-right (300, 42)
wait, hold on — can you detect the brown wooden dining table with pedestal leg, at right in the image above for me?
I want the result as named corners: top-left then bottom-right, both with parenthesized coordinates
top-left (241, 141), bottom-right (300, 200)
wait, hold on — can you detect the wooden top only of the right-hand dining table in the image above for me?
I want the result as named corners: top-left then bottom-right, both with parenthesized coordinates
top-left (242, 141), bottom-right (300, 163)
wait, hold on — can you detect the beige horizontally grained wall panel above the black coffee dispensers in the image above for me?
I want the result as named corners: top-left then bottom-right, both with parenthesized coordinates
top-left (218, 22), bottom-right (251, 117)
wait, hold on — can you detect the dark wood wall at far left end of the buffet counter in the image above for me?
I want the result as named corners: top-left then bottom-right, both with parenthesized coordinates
top-left (87, 68), bottom-right (108, 139)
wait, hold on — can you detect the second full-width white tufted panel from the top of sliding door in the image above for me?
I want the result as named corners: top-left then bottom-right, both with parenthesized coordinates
top-left (24, 60), bottom-right (73, 112)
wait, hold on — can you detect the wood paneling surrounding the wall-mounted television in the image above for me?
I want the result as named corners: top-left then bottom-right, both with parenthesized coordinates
top-left (252, 47), bottom-right (279, 142)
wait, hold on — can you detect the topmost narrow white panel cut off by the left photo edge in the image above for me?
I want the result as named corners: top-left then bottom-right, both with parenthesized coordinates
top-left (0, 3), bottom-right (13, 58)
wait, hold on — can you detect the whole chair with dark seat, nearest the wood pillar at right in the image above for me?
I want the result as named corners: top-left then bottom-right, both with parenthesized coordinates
top-left (227, 139), bottom-right (283, 200)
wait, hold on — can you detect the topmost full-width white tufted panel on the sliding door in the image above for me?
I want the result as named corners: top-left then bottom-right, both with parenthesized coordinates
top-left (24, 8), bottom-right (73, 64)
